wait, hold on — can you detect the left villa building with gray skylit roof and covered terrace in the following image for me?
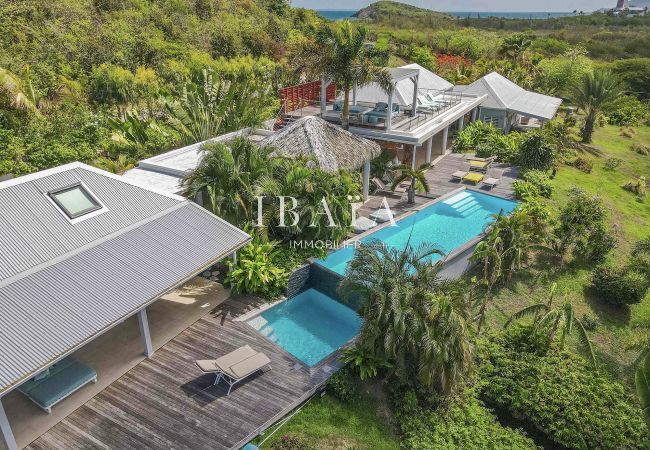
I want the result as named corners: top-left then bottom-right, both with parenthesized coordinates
top-left (0, 163), bottom-right (250, 450)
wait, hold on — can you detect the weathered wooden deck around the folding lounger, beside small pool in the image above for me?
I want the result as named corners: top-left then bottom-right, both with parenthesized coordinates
top-left (26, 300), bottom-right (338, 449)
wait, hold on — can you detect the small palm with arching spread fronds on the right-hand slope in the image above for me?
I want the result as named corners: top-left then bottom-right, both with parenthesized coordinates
top-left (505, 283), bottom-right (596, 368)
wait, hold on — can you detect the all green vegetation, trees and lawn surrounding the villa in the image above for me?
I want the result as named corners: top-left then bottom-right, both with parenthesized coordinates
top-left (0, 0), bottom-right (650, 449)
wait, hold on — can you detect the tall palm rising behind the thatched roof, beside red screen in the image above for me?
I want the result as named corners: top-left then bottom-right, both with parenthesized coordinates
top-left (292, 20), bottom-right (393, 130)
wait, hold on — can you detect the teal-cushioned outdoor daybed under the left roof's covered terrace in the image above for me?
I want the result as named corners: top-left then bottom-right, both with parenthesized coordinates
top-left (18, 356), bottom-right (97, 414)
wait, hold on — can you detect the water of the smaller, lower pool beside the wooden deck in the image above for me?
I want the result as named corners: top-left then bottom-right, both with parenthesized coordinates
top-left (247, 289), bottom-right (362, 367)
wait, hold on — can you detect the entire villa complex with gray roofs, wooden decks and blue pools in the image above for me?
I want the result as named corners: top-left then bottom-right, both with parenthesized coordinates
top-left (0, 64), bottom-right (540, 450)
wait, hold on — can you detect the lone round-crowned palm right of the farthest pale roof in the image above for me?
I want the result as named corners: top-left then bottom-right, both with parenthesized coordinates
top-left (571, 70), bottom-right (623, 144)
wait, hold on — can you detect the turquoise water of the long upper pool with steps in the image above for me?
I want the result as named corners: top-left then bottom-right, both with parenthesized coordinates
top-left (316, 190), bottom-right (517, 275)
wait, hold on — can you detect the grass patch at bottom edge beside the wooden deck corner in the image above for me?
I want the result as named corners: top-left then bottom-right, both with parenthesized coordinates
top-left (252, 386), bottom-right (399, 450)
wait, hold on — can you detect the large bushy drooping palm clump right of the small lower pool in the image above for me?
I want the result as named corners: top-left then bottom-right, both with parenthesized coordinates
top-left (339, 241), bottom-right (471, 393)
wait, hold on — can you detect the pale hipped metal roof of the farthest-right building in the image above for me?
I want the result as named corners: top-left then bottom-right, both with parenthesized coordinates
top-left (455, 72), bottom-right (562, 120)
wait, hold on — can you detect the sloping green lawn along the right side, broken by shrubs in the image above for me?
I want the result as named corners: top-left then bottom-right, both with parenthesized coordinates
top-left (489, 126), bottom-right (650, 383)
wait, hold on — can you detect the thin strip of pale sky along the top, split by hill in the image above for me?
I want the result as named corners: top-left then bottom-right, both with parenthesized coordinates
top-left (291, 0), bottom-right (616, 12)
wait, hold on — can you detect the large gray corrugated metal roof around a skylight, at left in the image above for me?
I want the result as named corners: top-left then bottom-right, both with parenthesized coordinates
top-left (0, 163), bottom-right (250, 394)
